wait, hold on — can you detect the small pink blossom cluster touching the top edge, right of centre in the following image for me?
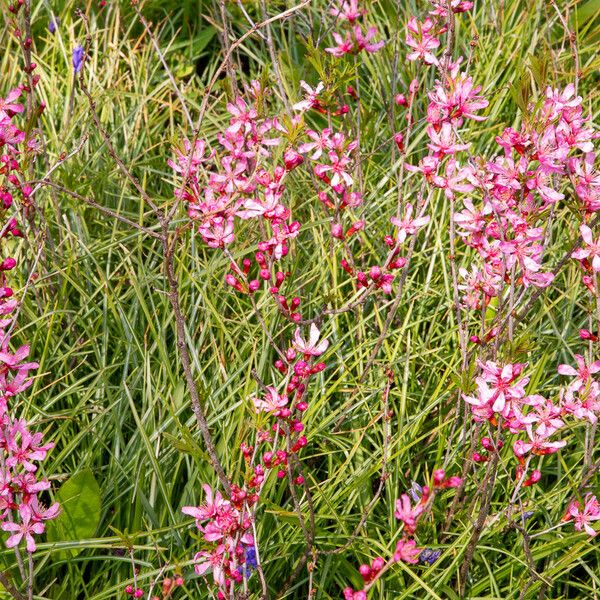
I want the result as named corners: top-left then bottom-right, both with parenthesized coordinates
top-left (325, 0), bottom-right (385, 57)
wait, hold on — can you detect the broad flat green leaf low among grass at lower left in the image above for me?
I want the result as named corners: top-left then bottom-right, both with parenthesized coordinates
top-left (47, 469), bottom-right (100, 559)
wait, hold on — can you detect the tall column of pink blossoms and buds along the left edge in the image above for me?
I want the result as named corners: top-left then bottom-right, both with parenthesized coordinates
top-left (0, 88), bottom-right (60, 552)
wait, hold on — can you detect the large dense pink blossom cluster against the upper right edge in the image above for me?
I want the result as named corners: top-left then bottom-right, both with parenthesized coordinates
top-left (455, 85), bottom-right (600, 309)
